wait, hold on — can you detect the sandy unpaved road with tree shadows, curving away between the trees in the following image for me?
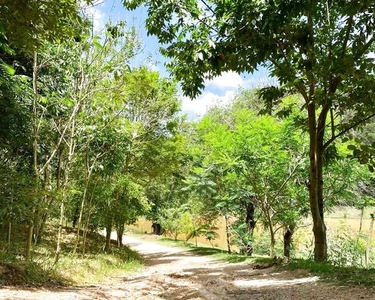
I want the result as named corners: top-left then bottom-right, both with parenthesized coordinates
top-left (0, 236), bottom-right (375, 300)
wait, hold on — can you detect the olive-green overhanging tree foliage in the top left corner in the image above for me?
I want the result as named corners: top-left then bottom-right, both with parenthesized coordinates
top-left (0, 0), bottom-right (84, 54)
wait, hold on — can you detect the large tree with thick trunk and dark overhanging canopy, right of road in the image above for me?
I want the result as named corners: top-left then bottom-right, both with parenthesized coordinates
top-left (124, 0), bottom-right (375, 261)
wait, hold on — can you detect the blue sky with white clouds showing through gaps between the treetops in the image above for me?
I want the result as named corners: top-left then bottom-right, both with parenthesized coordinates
top-left (86, 0), bottom-right (269, 120)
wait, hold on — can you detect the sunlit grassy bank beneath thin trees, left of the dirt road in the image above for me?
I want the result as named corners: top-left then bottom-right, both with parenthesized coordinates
top-left (0, 226), bottom-right (142, 286)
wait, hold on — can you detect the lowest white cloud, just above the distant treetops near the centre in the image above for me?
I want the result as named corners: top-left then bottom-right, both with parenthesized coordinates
top-left (182, 90), bottom-right (235, 117)
